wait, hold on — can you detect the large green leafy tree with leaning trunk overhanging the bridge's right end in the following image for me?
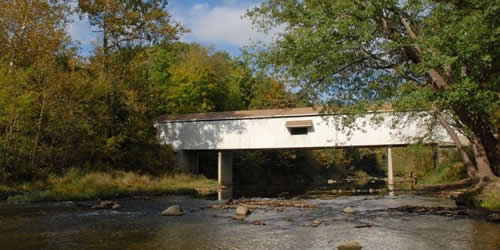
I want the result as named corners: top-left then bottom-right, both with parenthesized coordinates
top-left (248, 0), bottom-right (500, 179)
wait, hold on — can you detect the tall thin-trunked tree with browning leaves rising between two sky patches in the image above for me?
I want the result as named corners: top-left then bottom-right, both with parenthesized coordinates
top-left (77, 0), bottom-right (185, 138)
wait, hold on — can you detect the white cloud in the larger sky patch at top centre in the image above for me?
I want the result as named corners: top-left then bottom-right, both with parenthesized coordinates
top-left (173, 1), bottom-right (274, 46)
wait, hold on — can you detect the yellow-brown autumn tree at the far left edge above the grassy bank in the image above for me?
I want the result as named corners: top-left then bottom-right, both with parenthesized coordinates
top-left (0, 0), bottom-right (71, 180)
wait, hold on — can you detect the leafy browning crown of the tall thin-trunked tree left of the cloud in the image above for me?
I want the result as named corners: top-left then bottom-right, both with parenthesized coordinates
top-left (78, 0), bottom-right (185, 55)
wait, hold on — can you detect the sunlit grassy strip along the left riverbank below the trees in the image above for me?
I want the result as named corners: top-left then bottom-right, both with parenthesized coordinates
top-left (0, 170), bottom-right (217, 202)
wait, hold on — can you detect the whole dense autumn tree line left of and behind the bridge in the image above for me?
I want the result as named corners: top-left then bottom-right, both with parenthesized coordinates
top-left (0, 0), bottom-right (295, 184)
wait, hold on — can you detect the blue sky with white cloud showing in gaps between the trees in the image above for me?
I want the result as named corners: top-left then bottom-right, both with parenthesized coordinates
top-left (69, 0), bottom-right (273, 56)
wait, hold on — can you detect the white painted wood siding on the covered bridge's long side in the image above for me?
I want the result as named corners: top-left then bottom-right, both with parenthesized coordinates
top-left (155, 112), bottom-right (452, 151)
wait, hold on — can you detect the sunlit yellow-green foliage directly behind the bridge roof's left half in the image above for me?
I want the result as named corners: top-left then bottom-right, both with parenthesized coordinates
top-left (151, 43), bottom-right (278, 114)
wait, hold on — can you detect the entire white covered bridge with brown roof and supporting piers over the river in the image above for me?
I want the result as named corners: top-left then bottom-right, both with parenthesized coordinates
top-left (154, 108), bottom-right (458, 190)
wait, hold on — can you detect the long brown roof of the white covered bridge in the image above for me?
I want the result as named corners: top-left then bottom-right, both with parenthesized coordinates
top-left (154, 107), bottom-right (320, 122)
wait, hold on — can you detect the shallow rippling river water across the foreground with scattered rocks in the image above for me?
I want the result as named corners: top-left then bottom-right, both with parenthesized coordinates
top-left (0, 195), bottom-right (500, 250)
